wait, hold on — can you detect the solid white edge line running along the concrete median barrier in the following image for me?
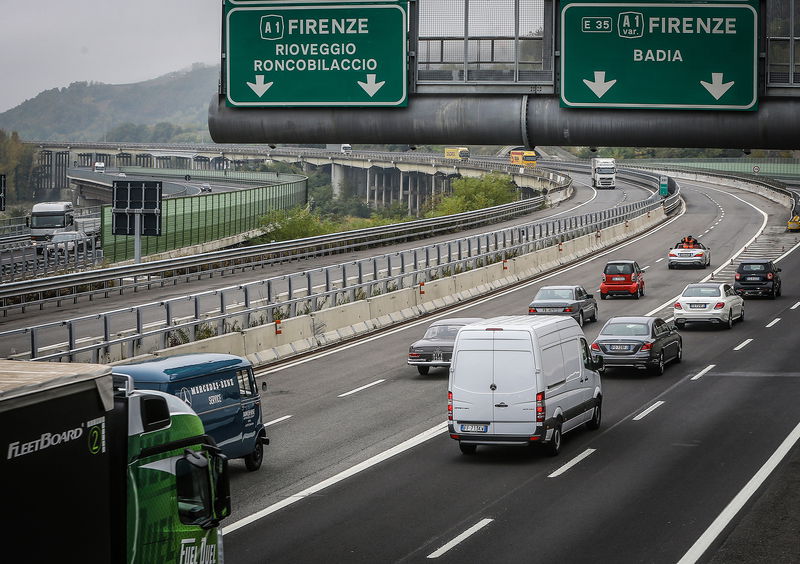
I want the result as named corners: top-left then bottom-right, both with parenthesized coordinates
top-left (256, 206), bottom-right (686, 376)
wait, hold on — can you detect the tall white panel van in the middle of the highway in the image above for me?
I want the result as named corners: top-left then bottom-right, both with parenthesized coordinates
top-left (447, 315), bottom-right (603, 456)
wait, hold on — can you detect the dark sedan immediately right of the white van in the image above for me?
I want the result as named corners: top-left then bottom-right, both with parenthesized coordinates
top-left (592, 316), bottom-right (683, 375)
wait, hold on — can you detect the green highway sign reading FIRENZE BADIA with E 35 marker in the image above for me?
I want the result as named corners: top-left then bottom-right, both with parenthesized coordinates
top-left (560, 0), bottom-right (758, 110)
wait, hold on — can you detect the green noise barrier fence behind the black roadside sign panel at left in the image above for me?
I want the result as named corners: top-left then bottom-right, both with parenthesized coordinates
top-left (102, 171), bottom-right (308, 262)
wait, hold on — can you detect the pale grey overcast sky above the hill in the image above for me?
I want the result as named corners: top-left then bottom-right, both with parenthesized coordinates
top-left (0, 0), bottom-right (221, 112)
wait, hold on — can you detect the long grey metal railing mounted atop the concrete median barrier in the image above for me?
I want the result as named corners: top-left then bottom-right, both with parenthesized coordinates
top-left (0, 176), bottom-right (678, 362)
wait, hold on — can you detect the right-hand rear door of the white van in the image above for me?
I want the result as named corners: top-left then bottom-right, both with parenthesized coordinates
top-left (492, 330), bottom-right (536, 435)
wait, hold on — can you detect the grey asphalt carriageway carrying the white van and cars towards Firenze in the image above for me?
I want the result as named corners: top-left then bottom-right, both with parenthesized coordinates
top-left (209, 177), bottom-right (800, 563)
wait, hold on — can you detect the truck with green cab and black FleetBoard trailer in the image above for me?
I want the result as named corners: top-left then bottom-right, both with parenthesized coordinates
top-left (0, 360), bottom-right (230, 564)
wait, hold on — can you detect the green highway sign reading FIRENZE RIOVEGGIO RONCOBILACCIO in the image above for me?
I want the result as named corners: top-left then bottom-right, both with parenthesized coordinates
top-left (224, 0), bottom-right (408, 107)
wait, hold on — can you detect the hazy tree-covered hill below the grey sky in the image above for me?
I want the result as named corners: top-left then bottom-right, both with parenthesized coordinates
top-left (0, 64), bottom-right (219, 142)
